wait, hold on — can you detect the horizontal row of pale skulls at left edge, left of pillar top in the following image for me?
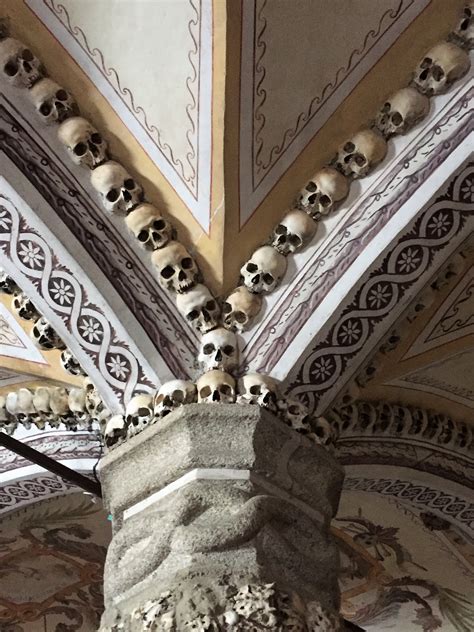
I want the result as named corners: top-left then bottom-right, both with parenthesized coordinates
top-left (0, 382), bottom-right (109, 434)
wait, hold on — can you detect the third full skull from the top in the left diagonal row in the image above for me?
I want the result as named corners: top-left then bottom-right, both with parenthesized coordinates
top-left (58, 116), bottom-right (107, 169)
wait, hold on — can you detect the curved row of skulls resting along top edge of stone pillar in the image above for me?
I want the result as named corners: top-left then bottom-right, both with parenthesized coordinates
top-left (104, 369), bottom-right (336, 449)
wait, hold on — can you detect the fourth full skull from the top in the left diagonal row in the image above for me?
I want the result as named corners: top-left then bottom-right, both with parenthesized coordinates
top-left (91, 160), bottom-right (143, 213)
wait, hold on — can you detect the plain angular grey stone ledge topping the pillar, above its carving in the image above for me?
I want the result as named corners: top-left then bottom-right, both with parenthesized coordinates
top-left (99, 404), bottom-right (344, 527)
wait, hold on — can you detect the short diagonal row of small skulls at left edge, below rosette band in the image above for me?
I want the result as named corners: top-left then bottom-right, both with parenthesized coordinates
top-left (0, 269), bottom-right (85, 376)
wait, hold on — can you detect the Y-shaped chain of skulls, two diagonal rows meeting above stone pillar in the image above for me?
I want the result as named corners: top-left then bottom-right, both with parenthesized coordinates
top-left (0, 0), bottom-right (474, 450)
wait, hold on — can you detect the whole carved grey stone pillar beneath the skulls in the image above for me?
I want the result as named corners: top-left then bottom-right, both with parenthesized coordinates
top-left (100, 404), bottom-right (343, 632)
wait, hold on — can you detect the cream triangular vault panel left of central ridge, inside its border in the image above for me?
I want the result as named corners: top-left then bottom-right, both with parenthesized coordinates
top-left (39, 0), bottom-right (203, 191)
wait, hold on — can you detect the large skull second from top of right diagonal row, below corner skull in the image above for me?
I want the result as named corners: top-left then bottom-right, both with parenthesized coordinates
top-left (413, 42), bottom-right (470, 97)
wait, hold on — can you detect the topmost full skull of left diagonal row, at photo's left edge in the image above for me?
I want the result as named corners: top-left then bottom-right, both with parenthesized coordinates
top-left (0, 37), bottom-right (43, 88)
